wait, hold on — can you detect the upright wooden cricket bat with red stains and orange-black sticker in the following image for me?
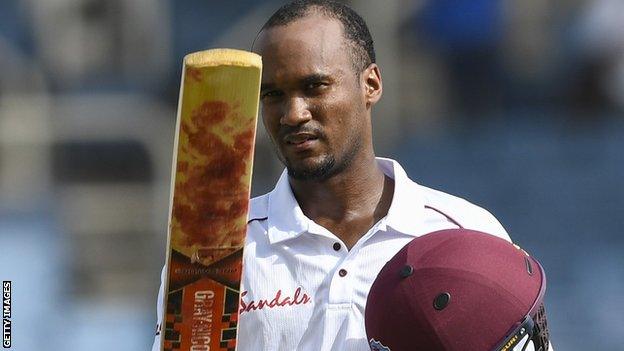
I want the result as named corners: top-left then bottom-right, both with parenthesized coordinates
top-left (161, 49), bottom-right (262, 351)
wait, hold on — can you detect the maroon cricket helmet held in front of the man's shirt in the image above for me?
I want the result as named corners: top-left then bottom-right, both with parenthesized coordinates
top-left (365, 229), bottom-right (548, 351)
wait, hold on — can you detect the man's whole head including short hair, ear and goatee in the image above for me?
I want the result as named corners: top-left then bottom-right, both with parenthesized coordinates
top-left (254, 1), bottom-right (382, 181)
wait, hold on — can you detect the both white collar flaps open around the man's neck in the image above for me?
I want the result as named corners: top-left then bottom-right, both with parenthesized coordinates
top-left (268, 157), bottom-right (424, 244)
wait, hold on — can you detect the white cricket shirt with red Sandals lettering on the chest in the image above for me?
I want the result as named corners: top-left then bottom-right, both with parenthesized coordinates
top-left (153, 158), bottom-right (510, 351)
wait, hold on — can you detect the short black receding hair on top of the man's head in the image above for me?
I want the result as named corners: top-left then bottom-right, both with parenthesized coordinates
top-left (260, 0), bottom-right (375, 72)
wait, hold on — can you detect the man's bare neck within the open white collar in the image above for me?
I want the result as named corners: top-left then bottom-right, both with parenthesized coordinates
top-left (289, 153), bottom-right (394, 248)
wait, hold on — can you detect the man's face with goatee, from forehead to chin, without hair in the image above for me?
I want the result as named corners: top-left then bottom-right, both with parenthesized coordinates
top-left (256, 14), bottom-right (370, 180)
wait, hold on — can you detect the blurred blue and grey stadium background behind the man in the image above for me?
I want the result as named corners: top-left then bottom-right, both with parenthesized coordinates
top-left (0, 0), bottom-right (624, 351)
